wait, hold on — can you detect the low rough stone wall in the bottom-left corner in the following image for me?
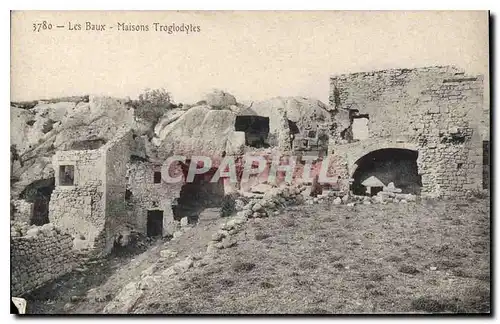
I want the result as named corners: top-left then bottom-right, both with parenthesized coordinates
top-left (10, 224), bottom-right (81, 296)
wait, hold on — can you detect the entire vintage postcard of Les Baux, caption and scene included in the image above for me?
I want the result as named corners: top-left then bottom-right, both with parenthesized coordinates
top-left (10, 11), bottom-right (491, 315)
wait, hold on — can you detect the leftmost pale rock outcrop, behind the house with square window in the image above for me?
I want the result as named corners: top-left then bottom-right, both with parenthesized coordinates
top-left (11, 97), bottom-right (140, 197)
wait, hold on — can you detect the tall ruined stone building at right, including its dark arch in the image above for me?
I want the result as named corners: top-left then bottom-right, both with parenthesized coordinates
top-left (329, 66), bottom-right (489, 197)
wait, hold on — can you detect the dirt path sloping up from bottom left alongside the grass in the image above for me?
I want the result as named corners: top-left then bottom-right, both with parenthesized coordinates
top-left (27, 209), bottom-right (224, 314)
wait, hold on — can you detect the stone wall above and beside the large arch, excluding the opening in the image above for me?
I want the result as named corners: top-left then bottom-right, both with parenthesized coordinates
top-left (330, 66), bottom-right (489, 197)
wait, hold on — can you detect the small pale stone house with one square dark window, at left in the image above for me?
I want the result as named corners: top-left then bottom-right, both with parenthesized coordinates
top-left (49, 130), bottom-right (132, 254)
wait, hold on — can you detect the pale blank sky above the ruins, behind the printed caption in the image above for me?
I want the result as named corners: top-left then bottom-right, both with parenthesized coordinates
top-left (11, 11), bottom-right (489, 103)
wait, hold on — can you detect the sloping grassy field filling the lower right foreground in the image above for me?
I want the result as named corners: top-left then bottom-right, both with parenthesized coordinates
top-left (132, 200), bottom-right (490, 314)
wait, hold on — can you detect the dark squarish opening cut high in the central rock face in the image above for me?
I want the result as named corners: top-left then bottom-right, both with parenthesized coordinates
top-left (234, 116), bottom-right (269, 148)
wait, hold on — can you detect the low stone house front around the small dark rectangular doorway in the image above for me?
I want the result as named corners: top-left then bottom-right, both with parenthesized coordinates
top-left (127, 161), bottom-right (184, 235)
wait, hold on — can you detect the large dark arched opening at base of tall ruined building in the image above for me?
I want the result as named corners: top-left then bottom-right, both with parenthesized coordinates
top-left (351, 148), bottom-right (422, 195)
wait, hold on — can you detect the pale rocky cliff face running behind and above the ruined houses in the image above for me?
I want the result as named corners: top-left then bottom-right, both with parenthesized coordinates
top-left (11, 91), bottom-right (331, 198)
